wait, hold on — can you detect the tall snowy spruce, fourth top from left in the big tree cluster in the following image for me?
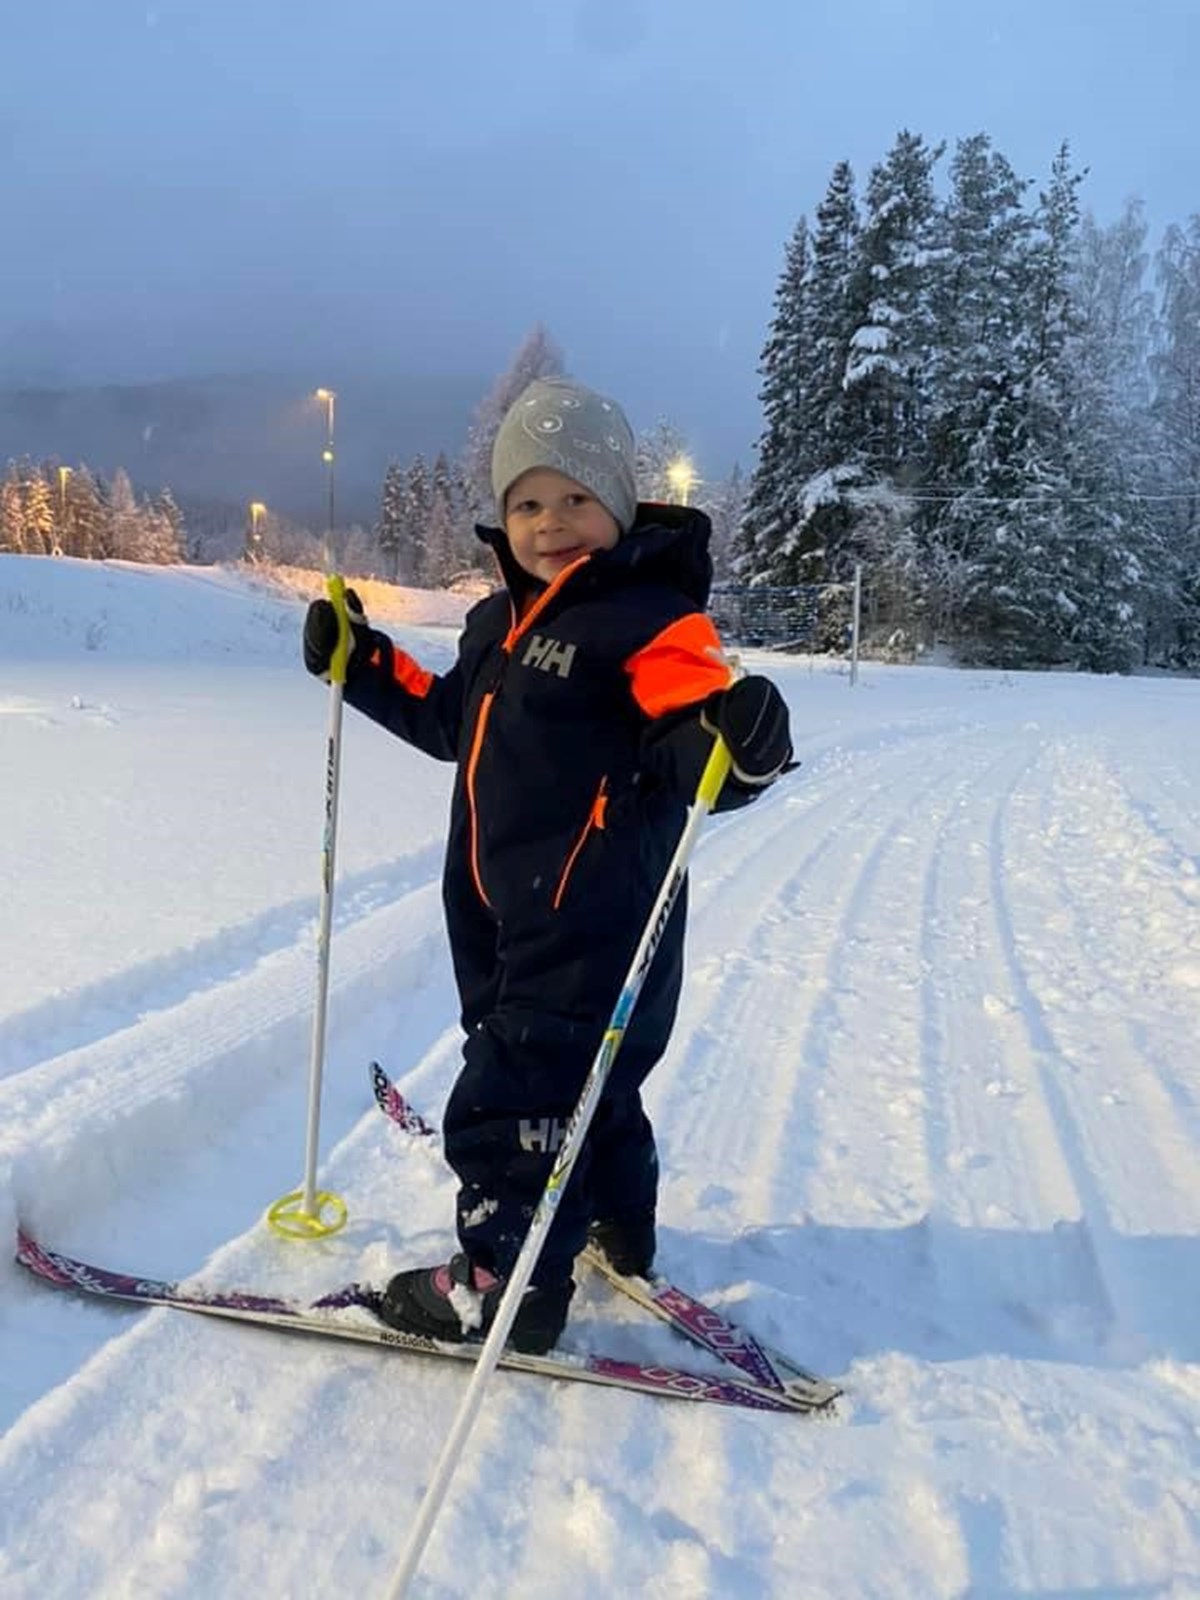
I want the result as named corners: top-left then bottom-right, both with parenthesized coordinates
top-left (917, 133), bottom-right (1032, 640)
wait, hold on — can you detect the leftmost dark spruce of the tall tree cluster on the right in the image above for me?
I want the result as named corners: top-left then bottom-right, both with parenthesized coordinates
top-left (731, 216), bottom-right (813, 582)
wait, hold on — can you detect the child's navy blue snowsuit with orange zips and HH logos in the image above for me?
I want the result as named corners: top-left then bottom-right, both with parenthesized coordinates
top-left (346, 506), bottom-right (754, 1283)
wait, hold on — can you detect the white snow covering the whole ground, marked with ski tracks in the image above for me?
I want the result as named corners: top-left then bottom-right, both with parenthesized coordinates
top-left (0, 555), bottom-right (1200, 1600)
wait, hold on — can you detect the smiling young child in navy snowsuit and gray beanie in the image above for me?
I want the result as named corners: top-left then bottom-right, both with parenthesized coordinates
top-left (304, 378), bottom-right (792, 1354)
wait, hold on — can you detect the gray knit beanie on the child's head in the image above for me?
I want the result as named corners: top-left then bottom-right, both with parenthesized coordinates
top-left (491, 378), bottom-right (637, 533)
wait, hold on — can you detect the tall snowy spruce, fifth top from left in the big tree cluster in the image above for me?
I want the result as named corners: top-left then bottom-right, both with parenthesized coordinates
top-left (965, 144), bottom-right (1082, 667)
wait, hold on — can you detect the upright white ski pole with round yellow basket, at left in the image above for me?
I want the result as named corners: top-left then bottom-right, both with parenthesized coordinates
top-left (267, 573), bottom-right (350, 1238)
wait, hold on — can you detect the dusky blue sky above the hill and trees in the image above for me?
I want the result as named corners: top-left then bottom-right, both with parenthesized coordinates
top-left (0, 0), bottom-right (1200, 467)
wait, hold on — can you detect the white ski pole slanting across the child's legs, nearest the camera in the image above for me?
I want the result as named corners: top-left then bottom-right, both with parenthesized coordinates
top-left (387, 738), bottom-right (730, 1600)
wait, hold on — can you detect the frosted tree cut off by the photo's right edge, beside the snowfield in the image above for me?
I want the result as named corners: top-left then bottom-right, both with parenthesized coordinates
top-left (1150, 214), bottom-right (1200, 670)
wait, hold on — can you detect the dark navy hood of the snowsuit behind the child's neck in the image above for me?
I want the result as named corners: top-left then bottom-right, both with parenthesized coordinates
top-left (475, 502), bottom-right (712, 611)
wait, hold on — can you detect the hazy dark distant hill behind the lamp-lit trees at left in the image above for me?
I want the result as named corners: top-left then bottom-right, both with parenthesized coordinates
top-left (0, 373), bottom-right (488, 525)
